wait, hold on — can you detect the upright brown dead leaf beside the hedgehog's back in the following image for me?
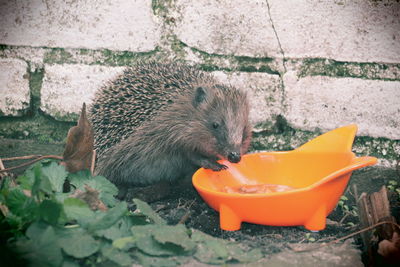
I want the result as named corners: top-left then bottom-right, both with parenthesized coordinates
top-left (61, 103), bottom-right (94, 172)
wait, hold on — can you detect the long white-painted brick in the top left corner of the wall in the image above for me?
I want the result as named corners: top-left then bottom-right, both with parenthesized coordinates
top-left (0, 0), bottom-right (160, 51)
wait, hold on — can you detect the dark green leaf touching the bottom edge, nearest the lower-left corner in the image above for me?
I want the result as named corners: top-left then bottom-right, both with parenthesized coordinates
top-left (16, 223), bottom-right (63, 266)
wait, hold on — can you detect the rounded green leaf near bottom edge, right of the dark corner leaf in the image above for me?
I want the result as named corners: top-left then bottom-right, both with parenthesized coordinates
top-left (59, 228), bottom-right (100, 259)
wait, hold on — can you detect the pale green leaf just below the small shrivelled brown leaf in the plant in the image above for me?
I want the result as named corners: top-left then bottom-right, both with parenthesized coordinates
top-left (64, 198), bottom-right (94, 226)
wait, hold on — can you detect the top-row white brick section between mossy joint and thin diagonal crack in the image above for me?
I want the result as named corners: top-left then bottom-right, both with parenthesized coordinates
top-left (175, 0), bottom-right (281, 57)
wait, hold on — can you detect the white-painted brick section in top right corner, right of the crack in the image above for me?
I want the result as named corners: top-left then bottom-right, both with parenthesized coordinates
top-left (268, 0), bottom-right (400, 63)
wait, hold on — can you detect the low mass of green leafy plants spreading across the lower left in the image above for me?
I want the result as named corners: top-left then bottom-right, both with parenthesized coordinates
top-left (0, 160), bottom-right (262, 266)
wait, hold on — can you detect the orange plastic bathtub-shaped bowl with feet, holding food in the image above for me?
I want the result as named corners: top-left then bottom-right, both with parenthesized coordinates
top-left (193, 125), bottom-right (377, 231)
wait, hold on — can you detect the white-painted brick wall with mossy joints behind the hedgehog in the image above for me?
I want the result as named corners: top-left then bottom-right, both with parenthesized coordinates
top-left (0, 0), bottom-right (400, 166)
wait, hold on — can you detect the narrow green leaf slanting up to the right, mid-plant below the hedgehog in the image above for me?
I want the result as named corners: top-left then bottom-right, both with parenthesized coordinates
top-left (87, 202), bottom-right (128, 231)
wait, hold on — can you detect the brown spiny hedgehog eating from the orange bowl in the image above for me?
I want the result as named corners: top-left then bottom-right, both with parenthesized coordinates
top-left (90, 62), bottom-right (251, 191)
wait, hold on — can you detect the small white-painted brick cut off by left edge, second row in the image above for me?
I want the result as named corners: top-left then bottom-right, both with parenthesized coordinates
top-left (0, 59), bottom-right (30, 116)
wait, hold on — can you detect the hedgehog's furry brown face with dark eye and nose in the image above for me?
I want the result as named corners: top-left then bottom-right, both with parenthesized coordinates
top-left (194, 86), bottom-right (251, 163)
